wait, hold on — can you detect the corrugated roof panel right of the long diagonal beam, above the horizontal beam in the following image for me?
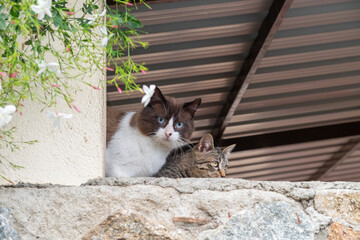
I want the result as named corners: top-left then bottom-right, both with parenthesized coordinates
top-left (224, 0), bottom-right (360, 138)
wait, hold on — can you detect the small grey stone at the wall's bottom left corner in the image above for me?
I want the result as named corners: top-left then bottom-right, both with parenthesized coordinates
top-left (0, 207), bottom-right (18, 240)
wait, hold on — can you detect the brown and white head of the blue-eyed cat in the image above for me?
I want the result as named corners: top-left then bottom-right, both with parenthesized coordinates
top-left (138, 87), bottom-right (201, 149)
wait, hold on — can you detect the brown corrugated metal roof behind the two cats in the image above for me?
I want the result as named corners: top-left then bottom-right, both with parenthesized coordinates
top-left (107, 0), bottom-right (360, 181)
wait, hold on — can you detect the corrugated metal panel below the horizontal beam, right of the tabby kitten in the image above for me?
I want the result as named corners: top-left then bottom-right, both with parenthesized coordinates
top-left (228, 137), bottom-right (356, 181)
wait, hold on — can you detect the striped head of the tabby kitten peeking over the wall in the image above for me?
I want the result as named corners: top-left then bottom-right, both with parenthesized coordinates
top-left (193, 134), bottom-right (236, 178)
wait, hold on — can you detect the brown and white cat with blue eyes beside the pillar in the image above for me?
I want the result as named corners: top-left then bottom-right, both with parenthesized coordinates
top-left (105, 87), bottom-right (201, 177)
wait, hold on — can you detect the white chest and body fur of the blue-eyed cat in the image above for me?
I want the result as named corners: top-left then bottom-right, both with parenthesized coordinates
top-left (105, 112), bottom-right (171, 177)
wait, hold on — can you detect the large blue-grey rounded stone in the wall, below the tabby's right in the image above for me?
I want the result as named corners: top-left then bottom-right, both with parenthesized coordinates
top-left (207, 202), bottom-right (315, 240)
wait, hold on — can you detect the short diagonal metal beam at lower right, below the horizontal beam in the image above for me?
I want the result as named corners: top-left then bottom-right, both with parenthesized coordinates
top-left (309, 138), bottom-right (360, 181)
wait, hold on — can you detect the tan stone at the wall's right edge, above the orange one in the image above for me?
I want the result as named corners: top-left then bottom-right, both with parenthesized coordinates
top-left (315, 190), bottom-right (360, 225)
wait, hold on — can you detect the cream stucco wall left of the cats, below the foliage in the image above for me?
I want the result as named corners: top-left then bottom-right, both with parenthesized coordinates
top-left (0, 0), bottom-right (106, 185)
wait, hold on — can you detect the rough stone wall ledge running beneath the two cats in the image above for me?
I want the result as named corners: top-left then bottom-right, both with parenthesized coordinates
top-left (0, 178), bottom-right (360, 240)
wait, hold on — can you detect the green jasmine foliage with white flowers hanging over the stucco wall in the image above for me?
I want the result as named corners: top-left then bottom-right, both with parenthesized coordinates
top-left (0, 0), bottom-right (147, 184)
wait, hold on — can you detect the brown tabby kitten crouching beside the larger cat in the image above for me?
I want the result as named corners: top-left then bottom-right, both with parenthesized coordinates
top-left (154, 134), bottom-right (236, 178)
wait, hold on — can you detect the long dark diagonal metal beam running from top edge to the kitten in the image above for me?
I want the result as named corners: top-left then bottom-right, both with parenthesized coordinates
top-left (212, 0), bottom-right (293, 142)
